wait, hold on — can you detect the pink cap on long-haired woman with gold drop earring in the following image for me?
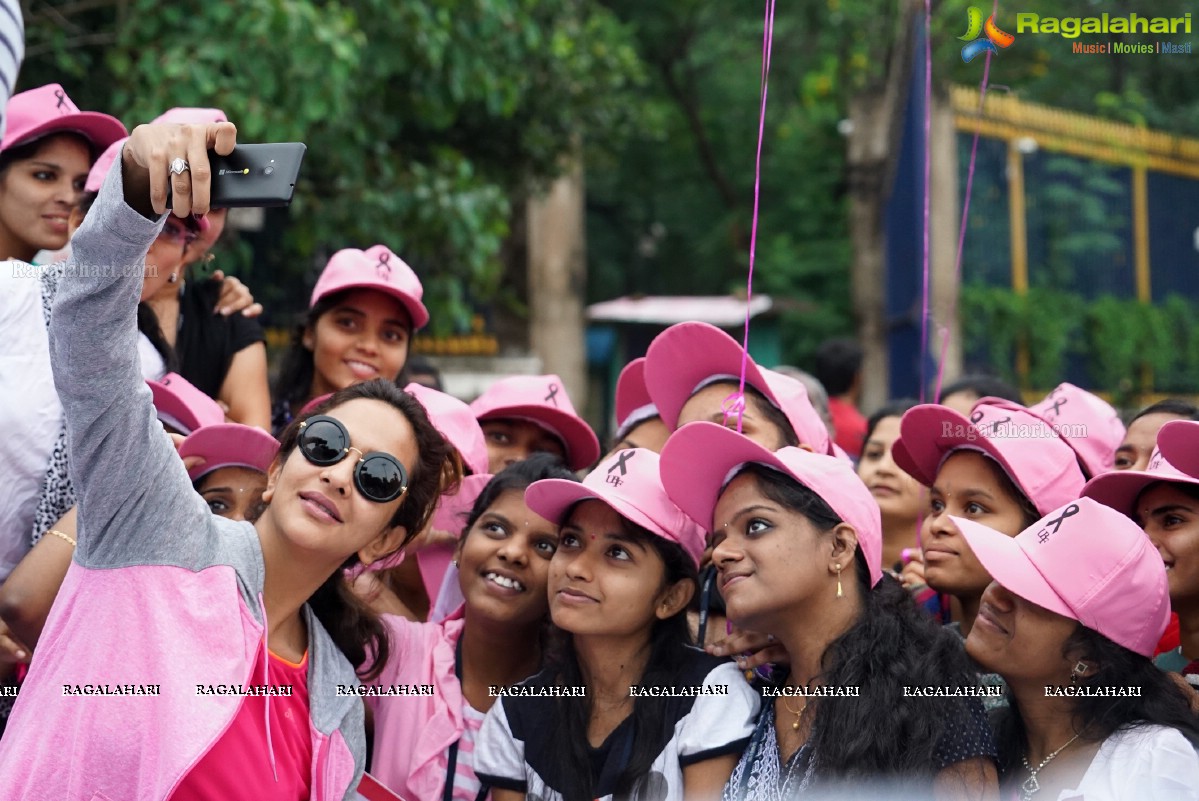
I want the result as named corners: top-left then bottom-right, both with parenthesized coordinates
top-left (661, 421), bottom-right (882, 586)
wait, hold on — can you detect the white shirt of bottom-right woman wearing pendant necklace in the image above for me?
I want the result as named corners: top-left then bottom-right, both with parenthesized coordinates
top-left (1058, 725), bottom-right (1199, 801)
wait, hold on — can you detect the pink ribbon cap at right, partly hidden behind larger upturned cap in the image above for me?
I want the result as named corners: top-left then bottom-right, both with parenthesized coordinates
top-left (1029, 384), bottom-right (1125, 476)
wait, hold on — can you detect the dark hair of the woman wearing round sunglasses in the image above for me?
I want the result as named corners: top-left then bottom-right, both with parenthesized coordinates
top-left (277, 379), bottom-right (460, 681)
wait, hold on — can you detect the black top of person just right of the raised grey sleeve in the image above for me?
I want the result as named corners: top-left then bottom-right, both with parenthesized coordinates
top-left (175, 279), bottom-right (266, 398)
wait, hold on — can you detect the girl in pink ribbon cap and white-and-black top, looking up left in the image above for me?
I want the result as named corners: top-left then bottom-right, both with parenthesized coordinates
top-left (475, 448), bottom-right (758, 801)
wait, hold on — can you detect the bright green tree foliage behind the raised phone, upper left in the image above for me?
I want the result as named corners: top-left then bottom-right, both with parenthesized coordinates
top-left (22, 0), bottom-right (641, 331)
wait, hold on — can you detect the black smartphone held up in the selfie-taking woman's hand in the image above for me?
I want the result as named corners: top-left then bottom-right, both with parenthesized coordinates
top-left (209, 141), bottom-right (308, 209)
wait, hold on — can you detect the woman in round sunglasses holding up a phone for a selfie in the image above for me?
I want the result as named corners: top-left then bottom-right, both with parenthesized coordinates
top-left (0, 122), bottom-right (453, 801)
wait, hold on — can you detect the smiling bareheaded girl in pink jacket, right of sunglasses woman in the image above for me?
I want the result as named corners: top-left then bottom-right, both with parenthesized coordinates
top-left (367, 454), bottom-right (574, 801)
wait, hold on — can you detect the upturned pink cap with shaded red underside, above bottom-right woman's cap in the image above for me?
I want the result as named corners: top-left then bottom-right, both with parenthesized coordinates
top-left (891, 398), bottom-right (1086, 514)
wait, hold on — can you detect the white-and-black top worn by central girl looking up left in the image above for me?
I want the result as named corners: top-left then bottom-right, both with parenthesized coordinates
top-left (475, 650), bottom-right (761, 801)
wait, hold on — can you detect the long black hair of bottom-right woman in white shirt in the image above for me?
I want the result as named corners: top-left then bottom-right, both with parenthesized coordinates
top-left (992, 624), bottom-right (1199, 777)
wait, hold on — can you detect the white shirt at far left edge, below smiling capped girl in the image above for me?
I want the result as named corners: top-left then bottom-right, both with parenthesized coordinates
top-left (0, 262), bottom-right (62, 582)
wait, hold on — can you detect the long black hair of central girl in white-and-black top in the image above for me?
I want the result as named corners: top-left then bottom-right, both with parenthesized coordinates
top-left (546, 514), bottom-right (697, 801)
